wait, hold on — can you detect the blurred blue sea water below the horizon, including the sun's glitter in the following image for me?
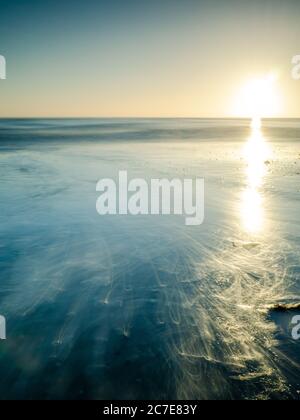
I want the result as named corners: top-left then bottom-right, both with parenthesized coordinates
top-left (0, 119), bottom-right (300, 400)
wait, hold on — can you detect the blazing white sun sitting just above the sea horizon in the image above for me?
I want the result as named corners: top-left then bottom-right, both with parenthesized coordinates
top-left (234, 74), bottom-right (282, 121)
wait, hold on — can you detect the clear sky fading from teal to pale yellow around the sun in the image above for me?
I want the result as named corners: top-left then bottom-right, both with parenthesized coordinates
top-left (0, 0), bottom-right (300, 117)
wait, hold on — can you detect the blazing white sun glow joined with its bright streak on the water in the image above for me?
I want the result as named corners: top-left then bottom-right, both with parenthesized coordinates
top-left (234, 74), bottom-right (282, 234)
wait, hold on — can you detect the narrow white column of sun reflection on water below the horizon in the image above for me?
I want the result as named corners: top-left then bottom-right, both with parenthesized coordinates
top-left (241, 119), bottom-right (271, 234)
